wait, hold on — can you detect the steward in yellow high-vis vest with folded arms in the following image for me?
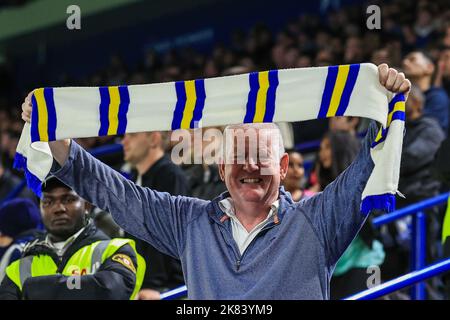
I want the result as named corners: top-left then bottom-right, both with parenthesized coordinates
top-left (0, 177), bottom-right (145, 300)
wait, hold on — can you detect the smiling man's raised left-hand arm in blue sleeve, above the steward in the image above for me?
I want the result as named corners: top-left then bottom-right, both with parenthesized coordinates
top-left (51, 141), bottom-right (207, 258)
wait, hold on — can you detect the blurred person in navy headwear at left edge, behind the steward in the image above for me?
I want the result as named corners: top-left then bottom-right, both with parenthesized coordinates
top-left (0, 198), bottom-right (42, 283)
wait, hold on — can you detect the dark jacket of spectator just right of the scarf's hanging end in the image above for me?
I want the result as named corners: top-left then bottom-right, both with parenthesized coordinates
top-left (399, 117), bottom-right (445, 205)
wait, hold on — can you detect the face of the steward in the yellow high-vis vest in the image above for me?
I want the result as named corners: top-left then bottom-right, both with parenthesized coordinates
top-left (41, 187), bottom-right (87, 241)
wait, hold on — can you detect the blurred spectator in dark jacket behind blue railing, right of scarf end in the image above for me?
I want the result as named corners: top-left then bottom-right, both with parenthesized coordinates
top-left (382, 86), bottom-right (444, 288)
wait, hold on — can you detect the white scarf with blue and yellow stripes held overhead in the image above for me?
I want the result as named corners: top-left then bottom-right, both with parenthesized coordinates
top-left (15, 64), bottom-right (405, 213)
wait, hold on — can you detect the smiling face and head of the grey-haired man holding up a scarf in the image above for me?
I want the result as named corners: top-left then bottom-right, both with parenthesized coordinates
top-left (219, 125), bottom-right (289, 205)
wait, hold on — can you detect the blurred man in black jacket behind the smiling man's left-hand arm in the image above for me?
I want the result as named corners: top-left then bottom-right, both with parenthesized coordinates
top-left (122, 131), bottom-right (189, 300)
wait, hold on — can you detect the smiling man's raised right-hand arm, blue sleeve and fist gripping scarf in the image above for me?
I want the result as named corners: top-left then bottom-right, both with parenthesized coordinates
top-left (304, 65), bottom-right (411, 265)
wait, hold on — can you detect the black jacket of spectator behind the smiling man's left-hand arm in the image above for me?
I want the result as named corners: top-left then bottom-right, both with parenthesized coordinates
top-left (126, 155), bottom-right (188, 291)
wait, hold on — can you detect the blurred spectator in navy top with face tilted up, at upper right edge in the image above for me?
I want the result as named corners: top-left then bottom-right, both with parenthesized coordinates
top-left (403, 51), bottom-right (450, 132)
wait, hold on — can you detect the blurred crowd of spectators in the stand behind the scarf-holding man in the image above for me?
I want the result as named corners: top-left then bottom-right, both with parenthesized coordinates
top-left (0, 0), bottom-right (450, 299)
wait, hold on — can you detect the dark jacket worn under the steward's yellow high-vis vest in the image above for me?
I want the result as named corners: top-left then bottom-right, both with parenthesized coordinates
top-left (0, 223), bottom-right (137, 300)
